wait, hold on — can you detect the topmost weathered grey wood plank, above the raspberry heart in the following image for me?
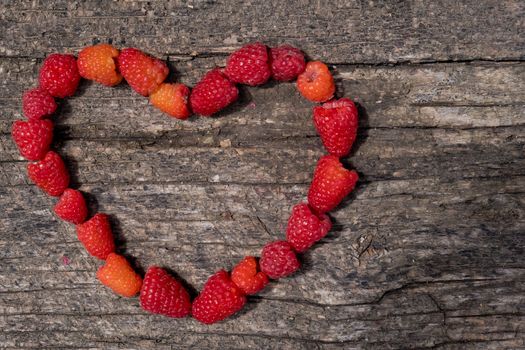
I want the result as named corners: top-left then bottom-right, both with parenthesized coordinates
top-left (0, 0), bottom-right (525, 63)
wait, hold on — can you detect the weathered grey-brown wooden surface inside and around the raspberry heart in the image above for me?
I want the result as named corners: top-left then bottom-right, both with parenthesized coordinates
top-left (0, 0), bottom-right (525, 350)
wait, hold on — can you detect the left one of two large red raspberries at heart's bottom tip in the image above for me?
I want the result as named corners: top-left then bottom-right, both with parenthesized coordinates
top-left (140, 266), bottom-right (191, 318)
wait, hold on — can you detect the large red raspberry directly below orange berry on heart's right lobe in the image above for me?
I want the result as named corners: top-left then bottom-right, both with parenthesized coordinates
top-left (314, 98), bottom-right (357, 157)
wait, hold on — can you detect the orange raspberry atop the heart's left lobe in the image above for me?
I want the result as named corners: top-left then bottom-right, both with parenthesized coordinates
top-left (77, 44), bottom-right (122, 86)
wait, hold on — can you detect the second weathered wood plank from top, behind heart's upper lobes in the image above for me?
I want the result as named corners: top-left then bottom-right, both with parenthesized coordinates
top-left (0, 58), bottom-right (525, 133)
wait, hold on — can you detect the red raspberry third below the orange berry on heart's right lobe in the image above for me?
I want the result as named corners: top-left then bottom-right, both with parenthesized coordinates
top-left (286, 203), bottom-right (332, 253)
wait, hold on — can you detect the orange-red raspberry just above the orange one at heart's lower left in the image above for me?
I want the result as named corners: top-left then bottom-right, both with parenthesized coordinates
top-left (77, 213), bottom-right (115, 260)
